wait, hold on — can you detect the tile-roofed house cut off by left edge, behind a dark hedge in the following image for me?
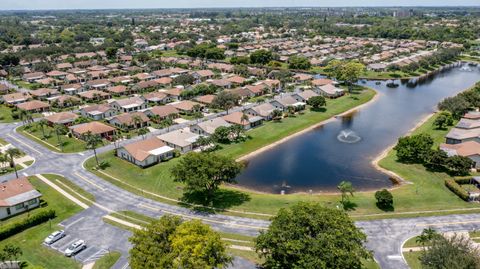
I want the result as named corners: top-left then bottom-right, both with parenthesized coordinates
top-left (0, 177), bottom-right (42, 220)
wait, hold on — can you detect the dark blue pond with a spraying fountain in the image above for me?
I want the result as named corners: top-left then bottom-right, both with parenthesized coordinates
top-left (237, 63), bottom-right (480, 193)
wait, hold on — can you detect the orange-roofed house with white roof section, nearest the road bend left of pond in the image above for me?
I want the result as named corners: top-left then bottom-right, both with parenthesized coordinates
top-left (117, 137), bottom-right (174, 168)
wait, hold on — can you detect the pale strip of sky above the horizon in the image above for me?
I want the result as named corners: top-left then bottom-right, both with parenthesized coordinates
top-left (0, 0), bottom-right (480, 10)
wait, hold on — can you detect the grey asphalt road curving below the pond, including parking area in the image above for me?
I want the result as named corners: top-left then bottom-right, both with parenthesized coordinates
top-left (4, 121), bottom-right (480, 269)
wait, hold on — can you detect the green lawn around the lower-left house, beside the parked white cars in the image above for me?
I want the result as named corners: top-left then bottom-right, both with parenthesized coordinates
top-left (0, 177), bottom-right (81, 269)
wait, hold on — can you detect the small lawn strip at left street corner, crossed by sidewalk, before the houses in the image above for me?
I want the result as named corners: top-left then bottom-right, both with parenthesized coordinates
top-left (17, 124), bottom-right (86, 153)
